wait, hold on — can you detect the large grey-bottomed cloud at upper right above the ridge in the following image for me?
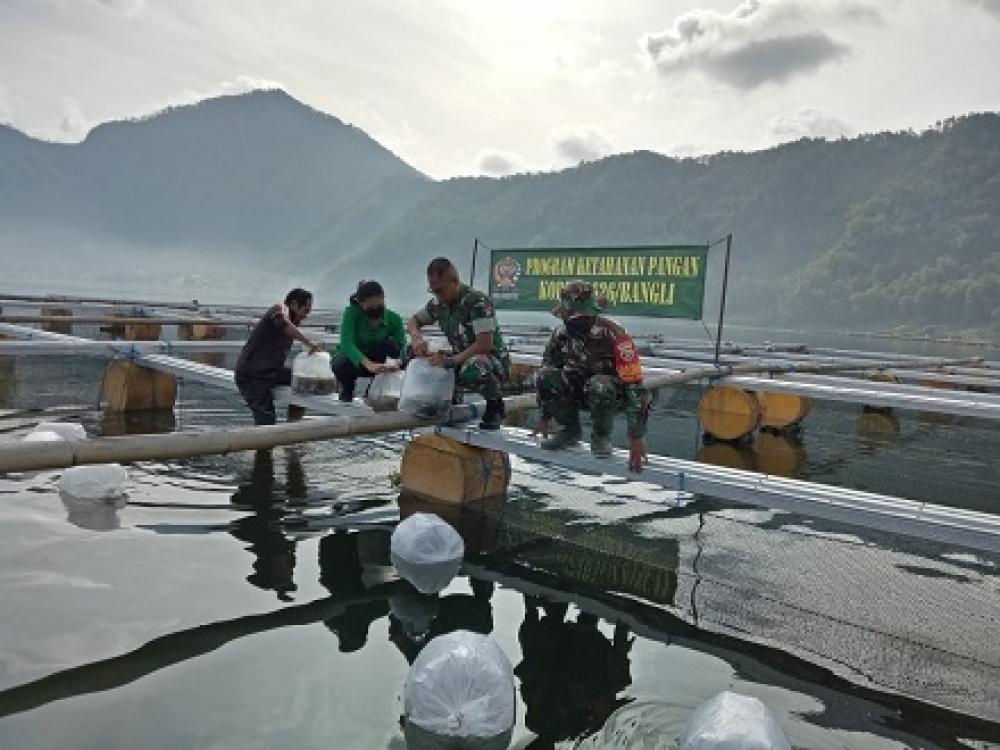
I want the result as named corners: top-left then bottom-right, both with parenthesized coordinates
top-left (640, 0), bottom-right (880, 89)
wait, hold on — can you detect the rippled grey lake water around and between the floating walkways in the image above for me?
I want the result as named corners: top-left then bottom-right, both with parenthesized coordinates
top-left (0, 335), bottom-right (1000, 749)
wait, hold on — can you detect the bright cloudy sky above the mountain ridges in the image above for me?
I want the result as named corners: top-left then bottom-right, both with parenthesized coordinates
top-left (0, 0), bottom-right (1000, 177)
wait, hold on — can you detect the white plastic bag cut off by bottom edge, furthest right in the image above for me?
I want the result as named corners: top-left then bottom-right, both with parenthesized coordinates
top-left (681, 690), bottom-right (791, 750)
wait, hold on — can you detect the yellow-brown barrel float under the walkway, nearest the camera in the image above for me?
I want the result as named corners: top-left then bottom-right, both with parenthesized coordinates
top-left (400, 435), bottom-right (510, 505)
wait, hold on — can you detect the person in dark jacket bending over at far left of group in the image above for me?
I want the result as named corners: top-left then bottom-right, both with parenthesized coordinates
top-left (236, 288), bottom-right (320, 425)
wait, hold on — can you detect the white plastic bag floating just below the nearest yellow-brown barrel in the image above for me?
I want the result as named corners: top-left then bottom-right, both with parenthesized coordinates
top-left (389, 513), bottom-right (465, 594)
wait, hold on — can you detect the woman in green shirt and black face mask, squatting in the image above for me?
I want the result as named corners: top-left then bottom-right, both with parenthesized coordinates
top-left (330, 281), bottom-right (406, 401)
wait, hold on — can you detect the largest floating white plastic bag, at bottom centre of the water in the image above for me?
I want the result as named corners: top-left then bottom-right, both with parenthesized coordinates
top-left (403, 630), bottom-right (514, 748)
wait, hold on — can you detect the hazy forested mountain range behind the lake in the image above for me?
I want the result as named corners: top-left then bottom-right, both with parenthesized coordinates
top-left (0, 91), bottom-right (1000, 330)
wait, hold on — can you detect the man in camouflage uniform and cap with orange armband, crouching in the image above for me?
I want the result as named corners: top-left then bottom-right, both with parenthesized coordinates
top-left (536, 281), bottom-right (650, 472)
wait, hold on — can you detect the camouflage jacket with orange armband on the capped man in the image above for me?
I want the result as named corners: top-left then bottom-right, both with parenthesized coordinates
top-left (542, 315), bottom-right (650, 437)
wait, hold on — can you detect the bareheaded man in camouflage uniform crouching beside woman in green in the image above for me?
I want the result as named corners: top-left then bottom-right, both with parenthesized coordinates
top-left (406, 258), bottom-right (510, 430)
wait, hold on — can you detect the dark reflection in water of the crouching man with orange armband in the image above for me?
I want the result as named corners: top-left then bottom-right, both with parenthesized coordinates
top-left (514, 596), bottom-right (635, 748)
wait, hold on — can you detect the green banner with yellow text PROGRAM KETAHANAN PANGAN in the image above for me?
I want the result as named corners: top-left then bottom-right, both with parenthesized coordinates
top-left (490, 245), bottom-right (708, 320)
